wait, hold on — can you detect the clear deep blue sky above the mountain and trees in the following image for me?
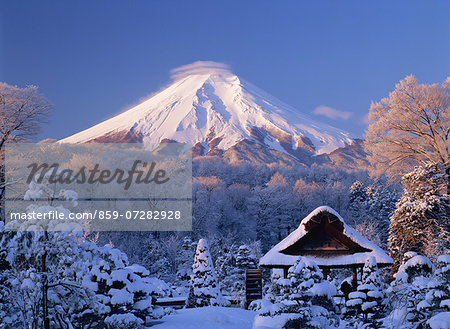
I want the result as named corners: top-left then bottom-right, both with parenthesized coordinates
top-left (0, 0), bottom-right (450, 139)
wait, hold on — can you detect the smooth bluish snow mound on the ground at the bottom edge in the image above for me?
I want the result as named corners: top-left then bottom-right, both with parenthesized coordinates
top-left (152, 306), bottom-right (256, 329)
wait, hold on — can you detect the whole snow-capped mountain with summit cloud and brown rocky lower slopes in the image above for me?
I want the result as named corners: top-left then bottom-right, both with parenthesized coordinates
top-left (61, 62), bottom-right (366, 164)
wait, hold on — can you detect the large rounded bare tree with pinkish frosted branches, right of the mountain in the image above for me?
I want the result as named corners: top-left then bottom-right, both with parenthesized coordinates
top-left (365, 75), bottom-right (450, 194)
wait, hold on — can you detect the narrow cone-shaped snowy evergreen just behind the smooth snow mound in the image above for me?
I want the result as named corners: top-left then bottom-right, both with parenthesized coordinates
top-left (187, 239), bottom-right (227, 307)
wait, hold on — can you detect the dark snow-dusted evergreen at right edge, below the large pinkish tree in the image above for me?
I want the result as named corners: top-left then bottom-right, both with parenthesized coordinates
top-left (388, 163), bottom-right (450, 271)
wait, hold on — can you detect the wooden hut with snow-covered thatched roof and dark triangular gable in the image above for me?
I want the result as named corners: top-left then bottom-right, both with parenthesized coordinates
top-left (259, 207), bottom-right (393, 285)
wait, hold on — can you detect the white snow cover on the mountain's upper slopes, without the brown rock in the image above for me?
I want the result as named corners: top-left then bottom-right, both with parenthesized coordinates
top-left (62, 68), bottom-right (353, 154)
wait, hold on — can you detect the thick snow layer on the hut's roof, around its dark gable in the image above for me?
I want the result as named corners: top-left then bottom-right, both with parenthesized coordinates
top-left (259, 206), bottom-right (393, 267)
